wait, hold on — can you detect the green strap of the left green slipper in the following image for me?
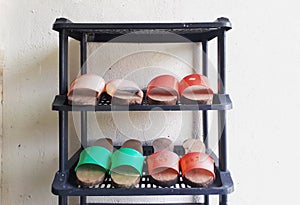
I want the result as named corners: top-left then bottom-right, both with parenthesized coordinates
top-left (75, 146), bottom-right (111, 171)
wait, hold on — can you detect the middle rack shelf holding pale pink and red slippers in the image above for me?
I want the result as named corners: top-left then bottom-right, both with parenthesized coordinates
top-left (52, 93), bottom-right (232, 111)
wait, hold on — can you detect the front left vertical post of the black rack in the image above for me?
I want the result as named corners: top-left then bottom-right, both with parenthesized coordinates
top-left (58, 29), bottom-right (68, 205)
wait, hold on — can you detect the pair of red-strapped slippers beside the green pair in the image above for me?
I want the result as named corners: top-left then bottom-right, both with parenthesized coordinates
top-left (147, 138), bottom-right (216, 187)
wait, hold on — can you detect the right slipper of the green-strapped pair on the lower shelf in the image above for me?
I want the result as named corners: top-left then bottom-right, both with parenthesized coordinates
top-left (110, 139), bottom-right (144, 188)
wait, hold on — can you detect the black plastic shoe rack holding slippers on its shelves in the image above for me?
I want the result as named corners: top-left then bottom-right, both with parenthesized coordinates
top-left (52, 18), bottom-right (233, 205)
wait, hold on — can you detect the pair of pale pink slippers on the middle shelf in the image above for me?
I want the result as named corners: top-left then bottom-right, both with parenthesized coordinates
top-left (67, 74), bottom-right (144, 105)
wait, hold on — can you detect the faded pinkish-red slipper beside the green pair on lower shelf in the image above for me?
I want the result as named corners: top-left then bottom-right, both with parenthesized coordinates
top-left (147, 138), bottom-right (179, 187)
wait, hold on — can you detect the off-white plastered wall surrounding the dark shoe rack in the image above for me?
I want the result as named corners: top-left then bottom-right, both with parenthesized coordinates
top-left (0, 0), bottom-right (300, 205)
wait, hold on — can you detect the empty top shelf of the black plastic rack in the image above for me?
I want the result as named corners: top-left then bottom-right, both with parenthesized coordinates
top-left (53, 17), bottom-right (231, 43)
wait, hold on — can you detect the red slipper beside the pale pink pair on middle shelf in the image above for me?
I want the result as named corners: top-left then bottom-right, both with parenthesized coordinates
top-left (146, 75), bottom-right (179, 105)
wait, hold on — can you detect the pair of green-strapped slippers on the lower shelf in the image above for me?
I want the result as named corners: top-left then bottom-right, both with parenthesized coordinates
top-left (75, 138), bottom-right (144, 188)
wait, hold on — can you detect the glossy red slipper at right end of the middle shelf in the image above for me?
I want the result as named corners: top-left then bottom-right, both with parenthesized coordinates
top-left (179, 74), bottom-right (214, 104)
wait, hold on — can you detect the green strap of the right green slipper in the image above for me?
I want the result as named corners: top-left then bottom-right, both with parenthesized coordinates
top-left (110, 147), bottom-right (144, 175)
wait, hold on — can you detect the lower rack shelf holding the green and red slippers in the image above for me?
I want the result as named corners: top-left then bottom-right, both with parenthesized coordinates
top-left (52, 146), bottom-right (233, 196)
